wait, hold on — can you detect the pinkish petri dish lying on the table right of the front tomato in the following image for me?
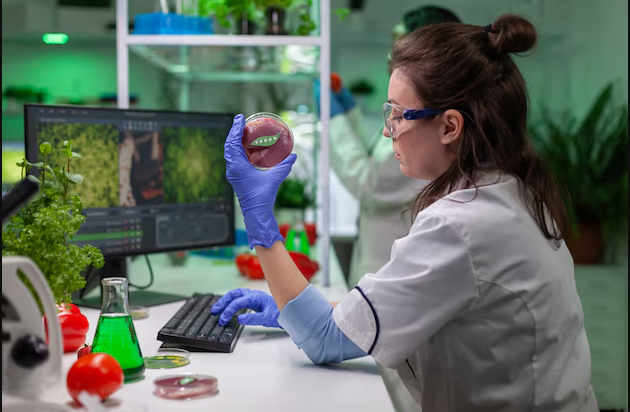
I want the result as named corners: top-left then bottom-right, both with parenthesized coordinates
top-left (153, 373), bottom-right (219, 400)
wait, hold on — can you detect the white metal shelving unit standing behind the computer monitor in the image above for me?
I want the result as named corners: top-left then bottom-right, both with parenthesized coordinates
top-left (116, 0), bottom-right (330, 286)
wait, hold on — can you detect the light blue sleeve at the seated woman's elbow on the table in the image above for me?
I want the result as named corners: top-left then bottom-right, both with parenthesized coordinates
top-left (278, 285), bottom-right (367, 364)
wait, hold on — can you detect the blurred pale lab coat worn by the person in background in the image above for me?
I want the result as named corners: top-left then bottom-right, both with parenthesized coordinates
top-left (330, 109), bottom-right (426, 287)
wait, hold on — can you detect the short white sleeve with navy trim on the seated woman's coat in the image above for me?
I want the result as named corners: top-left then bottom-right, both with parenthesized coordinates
top-left (333, 216), bottom-right (478, 367)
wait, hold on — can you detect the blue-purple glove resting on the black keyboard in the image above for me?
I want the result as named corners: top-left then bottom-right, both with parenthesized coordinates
top-left (210, 288), bottom-right (282, 328)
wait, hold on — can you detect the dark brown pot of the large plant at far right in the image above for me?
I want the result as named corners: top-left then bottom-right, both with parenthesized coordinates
top-left (564, 222), bottom-right (605, 265)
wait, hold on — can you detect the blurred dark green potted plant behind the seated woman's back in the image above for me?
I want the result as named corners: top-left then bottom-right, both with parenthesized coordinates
top-left (529, 84), bottom-right (628, 264)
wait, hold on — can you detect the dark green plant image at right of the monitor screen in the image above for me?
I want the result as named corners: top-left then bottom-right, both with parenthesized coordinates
top-left (162, 127), bottom-right (232, 203)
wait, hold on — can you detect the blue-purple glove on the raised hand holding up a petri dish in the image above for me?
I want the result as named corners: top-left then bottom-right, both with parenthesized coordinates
top-left (224, 114), bottom-right (297, 249)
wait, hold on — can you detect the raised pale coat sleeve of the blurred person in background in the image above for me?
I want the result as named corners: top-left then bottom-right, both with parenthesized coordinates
top-left (330, 109), bottom-right (426, 207)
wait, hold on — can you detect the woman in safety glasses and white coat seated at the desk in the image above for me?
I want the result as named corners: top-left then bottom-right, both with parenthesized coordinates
top-left (212, 15), bottom-right (597, 412)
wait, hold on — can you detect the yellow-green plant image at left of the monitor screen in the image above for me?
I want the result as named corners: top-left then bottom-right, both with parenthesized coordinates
top-left (37, 123), bottom-right (119, 208)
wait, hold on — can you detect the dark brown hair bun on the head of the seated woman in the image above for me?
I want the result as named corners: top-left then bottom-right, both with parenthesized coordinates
top-left (486, 14), bottom-right (536, 54)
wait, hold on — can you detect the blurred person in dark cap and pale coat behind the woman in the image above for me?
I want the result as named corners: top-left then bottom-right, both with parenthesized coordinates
top-left (316, 6), bottom-right (460, 412)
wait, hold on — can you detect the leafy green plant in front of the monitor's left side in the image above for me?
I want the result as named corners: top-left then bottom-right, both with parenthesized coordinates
top-left (2, 140), bottom-right (104, 303)
